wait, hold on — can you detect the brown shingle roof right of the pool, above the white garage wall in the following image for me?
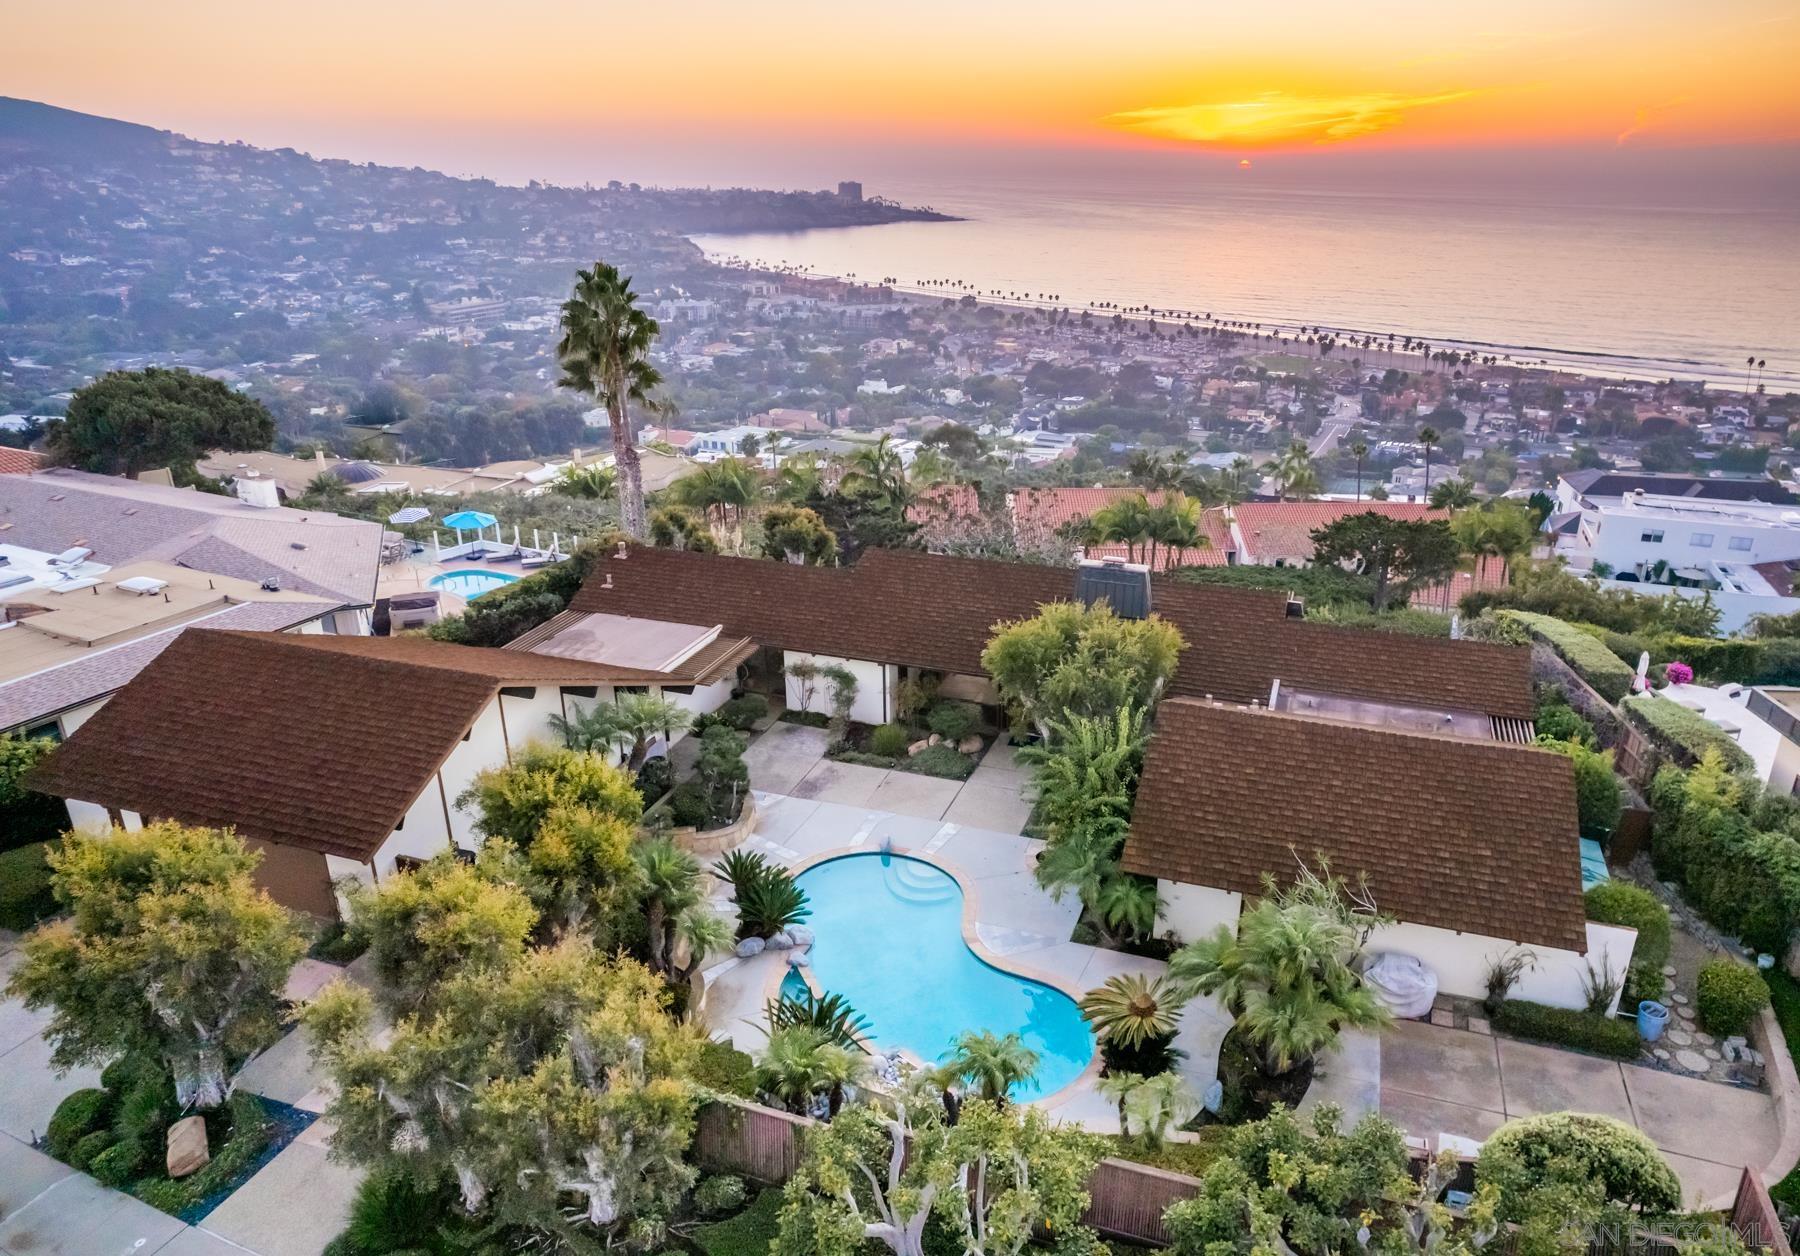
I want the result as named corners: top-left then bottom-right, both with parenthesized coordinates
top-left (1123, 698), bottom-right (1588, 959)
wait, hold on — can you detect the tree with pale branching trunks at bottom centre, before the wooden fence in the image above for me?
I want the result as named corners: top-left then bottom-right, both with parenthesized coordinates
top-left (770, 1094), bottom-right (1100, 1256)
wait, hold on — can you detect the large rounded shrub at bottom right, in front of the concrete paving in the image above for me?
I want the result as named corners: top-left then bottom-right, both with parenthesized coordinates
top-left (1474, 1112), bottom-right (1681, 1222)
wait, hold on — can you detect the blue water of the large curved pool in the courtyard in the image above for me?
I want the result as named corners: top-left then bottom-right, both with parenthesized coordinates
top-left (790, 855), bottom-right (1094, 1099)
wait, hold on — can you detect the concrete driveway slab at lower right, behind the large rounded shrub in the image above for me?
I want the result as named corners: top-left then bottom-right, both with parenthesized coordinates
top-left (1381, 1020), bottom-right (1780, 1204)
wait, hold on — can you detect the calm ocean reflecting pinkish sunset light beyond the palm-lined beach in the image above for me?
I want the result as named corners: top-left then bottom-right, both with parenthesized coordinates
top-left (695, 152), bottom-right (1800, 392)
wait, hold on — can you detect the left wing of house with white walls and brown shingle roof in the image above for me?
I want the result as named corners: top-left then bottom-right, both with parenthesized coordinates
top-left (31, 632), bottom-right (630, 916)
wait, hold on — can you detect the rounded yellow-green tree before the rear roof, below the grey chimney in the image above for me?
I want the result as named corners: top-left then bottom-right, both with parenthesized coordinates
top-left (981, 601), bottom-right (1186, 738)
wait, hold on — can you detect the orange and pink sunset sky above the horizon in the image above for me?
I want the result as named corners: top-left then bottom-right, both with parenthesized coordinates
top-left (0, 0), bottom-right (1800, 180)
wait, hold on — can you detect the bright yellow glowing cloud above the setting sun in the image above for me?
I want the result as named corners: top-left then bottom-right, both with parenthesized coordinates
top-left (1105, 90), bottom-right (1476, 148)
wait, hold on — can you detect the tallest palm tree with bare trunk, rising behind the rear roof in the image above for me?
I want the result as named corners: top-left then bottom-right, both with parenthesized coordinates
top-left (556, 261), bottom-right (662, 540)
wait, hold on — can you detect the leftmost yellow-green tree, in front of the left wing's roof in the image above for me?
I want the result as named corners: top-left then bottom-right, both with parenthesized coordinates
top-left (9, 822), bottom-right (306, 1110)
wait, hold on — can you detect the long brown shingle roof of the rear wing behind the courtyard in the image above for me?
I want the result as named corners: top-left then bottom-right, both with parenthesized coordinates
top-left (571, 547), bottom-right (1532, 718)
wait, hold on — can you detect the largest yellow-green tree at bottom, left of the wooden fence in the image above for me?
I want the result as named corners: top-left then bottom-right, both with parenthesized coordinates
top-left (306, 939), bottom-right (700, 1251)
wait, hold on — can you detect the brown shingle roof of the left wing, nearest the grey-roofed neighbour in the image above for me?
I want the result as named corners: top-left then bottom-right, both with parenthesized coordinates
top-left (32, 632), bottom-right (615, 860)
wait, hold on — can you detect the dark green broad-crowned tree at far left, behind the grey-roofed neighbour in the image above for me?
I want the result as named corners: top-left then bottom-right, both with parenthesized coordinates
top-left (45, 367), bottom-right (275, 484)
